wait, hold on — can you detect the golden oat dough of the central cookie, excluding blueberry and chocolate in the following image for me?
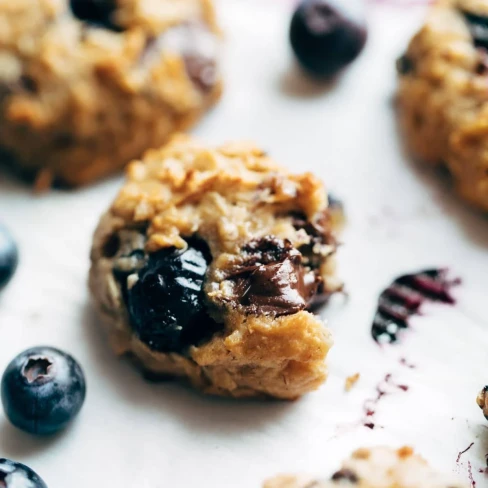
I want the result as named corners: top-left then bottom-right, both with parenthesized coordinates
top-left (90, 136), bottom-right (340, 399)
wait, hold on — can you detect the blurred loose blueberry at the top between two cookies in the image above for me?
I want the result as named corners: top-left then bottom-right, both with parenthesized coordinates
top-left (290, 0), bottom-right (367, 78)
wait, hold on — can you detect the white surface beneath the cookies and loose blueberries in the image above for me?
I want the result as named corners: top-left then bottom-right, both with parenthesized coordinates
top-left (0, 0), bottom-right (488, 488)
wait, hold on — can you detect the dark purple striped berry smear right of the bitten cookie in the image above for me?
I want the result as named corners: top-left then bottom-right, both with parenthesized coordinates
top-left (371, 269), bottom-right (461, 344)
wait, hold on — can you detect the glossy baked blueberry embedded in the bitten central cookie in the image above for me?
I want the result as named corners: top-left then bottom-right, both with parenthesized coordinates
top-left (127, 241), bottom-right (220, 352)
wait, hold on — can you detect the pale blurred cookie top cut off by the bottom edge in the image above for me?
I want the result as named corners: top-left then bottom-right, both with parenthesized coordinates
top-left (263, 447), bottom-right (466, 488)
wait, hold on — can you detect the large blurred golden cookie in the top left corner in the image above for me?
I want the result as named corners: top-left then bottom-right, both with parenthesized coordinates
top-left (0, 0), bottom-right (221, 186)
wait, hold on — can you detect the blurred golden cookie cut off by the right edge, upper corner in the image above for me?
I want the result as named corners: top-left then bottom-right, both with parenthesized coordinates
top-left (397, 0), bottom-right (488, 210)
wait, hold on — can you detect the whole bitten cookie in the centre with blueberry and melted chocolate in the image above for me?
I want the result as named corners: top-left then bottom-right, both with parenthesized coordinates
top-left (90, 135), bottom-right (341, 399)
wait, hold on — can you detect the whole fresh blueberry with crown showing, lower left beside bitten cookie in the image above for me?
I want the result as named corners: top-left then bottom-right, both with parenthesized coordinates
top-left (0, 347), bottom-right (86, 434)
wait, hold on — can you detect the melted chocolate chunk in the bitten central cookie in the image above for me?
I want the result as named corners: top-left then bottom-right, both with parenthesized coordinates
top-left (228, 236), bottom-right (321, 316)
